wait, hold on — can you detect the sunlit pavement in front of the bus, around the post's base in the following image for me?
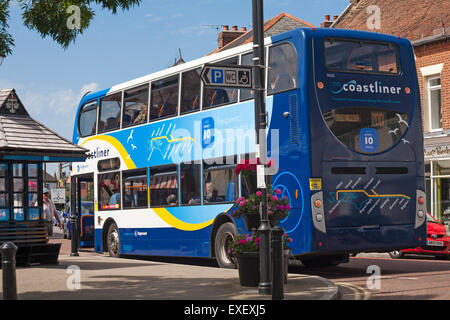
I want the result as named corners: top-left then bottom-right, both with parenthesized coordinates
top-left (0, 229), bottom-right (339, 300)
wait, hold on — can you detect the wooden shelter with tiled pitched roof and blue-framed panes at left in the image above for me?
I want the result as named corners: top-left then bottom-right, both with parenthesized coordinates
top-left (0, 89), bottom-right (88, 264)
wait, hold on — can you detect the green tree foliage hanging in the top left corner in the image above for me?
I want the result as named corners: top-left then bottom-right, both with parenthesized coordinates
top-left (0, 0), bottom-right (142, 57)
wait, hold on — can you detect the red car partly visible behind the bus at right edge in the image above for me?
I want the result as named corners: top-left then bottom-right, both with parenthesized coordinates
top-left (389, 213), bottom-right (450, 259)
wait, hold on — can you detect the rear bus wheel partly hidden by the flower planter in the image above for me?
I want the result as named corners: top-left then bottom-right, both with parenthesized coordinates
top-left (214, 222), bottom-right (237, 269)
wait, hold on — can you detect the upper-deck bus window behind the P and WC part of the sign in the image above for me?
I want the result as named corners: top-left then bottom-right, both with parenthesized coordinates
top-left (203, 57), bottom-right (238, 109)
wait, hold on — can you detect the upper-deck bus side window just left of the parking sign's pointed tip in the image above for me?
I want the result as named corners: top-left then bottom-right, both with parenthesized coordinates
top-left (180, 68), bottom-right (202, 114)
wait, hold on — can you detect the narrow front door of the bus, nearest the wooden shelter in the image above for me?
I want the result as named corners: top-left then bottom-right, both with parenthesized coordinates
top-left (75, 174), bottom-right (94, 248)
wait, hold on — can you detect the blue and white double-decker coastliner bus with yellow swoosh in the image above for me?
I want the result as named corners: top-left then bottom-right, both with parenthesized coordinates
top-left (72, 29), bottom-right (426, 267)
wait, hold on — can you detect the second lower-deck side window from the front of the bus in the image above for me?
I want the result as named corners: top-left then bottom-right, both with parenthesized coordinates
top-left (122, 169), bottom-right (148, 209)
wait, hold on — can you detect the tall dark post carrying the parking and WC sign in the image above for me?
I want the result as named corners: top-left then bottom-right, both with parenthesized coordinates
top-left (252, 0), bottom-right (272, 294)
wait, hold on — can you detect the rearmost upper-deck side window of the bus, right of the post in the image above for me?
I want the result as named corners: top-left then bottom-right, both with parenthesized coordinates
top-left (267, 43), bottom-right (297, 94)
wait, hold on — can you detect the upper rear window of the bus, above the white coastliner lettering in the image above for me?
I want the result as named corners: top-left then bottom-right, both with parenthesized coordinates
top-left (324, 39), bottom-right (400, 75)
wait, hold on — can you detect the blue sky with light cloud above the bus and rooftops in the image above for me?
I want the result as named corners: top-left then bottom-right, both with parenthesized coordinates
top-left (0, 0), bottom-right (349, 148)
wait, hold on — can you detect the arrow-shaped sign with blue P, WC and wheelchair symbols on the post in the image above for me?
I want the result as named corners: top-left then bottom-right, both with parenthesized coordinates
top-left (201, 64), bottom-right (253, 89)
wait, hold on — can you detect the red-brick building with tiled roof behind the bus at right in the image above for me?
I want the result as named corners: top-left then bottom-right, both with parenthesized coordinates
top-left (321, 0), bottom-right (450, 220)
